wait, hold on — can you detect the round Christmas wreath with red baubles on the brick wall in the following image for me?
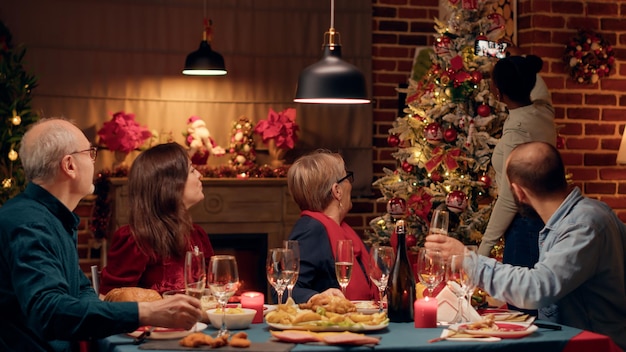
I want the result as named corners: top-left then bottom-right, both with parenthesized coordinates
top-left (563, 30), bottom-right (615, 84)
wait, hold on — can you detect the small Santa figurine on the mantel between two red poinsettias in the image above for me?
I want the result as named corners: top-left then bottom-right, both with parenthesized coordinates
top-left (186, 116), bottom-right (226, 165)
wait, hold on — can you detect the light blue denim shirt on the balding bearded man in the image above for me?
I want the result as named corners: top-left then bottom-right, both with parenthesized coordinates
top-left (472, 188), bottom-right (626, 349)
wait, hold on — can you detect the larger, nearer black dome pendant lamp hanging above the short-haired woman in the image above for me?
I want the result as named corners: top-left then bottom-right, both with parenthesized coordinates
top-left (293, 0), bottom-right (370, 104)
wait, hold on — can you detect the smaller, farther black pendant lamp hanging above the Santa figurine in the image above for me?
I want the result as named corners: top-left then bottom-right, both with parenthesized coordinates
top-left (183, 15), bottom-right (226, 76)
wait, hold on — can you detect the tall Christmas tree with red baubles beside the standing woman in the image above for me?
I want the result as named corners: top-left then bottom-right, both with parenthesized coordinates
top-left (366, 0), bottom-right (507, 253)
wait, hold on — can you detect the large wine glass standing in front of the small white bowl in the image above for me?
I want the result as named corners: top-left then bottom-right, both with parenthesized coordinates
top-left (208, 255), bottom-right (239, 337)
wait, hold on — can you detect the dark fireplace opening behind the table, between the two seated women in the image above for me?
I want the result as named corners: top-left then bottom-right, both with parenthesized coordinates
top-left (209, 233), bottom-right (268, 303)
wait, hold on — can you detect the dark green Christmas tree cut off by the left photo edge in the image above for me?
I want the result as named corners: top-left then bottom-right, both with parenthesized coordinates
top-left (0, 21), bottom-right (39, 205)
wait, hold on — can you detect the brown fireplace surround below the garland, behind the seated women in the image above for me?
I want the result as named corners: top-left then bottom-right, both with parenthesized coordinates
top-left (110, 177), bottom-right (300, 248)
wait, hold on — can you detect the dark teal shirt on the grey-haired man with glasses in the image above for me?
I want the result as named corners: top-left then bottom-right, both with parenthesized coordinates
top-left (0, 183), bottom-right (139, 351)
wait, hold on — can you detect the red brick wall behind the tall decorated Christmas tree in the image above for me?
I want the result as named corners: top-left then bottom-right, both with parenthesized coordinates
top-left (347, 0), bottom-right (626, 239)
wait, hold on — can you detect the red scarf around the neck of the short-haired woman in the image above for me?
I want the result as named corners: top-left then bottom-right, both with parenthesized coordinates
top-left (300, 210), bottom-right (378, 300)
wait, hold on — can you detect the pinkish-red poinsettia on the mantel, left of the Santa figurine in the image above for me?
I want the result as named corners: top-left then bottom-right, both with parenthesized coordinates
top-left (98, 111), bottom-right (152, 153)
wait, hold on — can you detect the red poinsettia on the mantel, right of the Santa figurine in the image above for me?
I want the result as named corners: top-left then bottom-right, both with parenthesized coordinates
top-left (254, 108), bottom-right (300, 150)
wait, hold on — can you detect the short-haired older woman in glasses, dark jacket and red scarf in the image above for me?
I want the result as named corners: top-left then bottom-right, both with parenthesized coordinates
top-left (287, 150), bottom-right (378, 303)
